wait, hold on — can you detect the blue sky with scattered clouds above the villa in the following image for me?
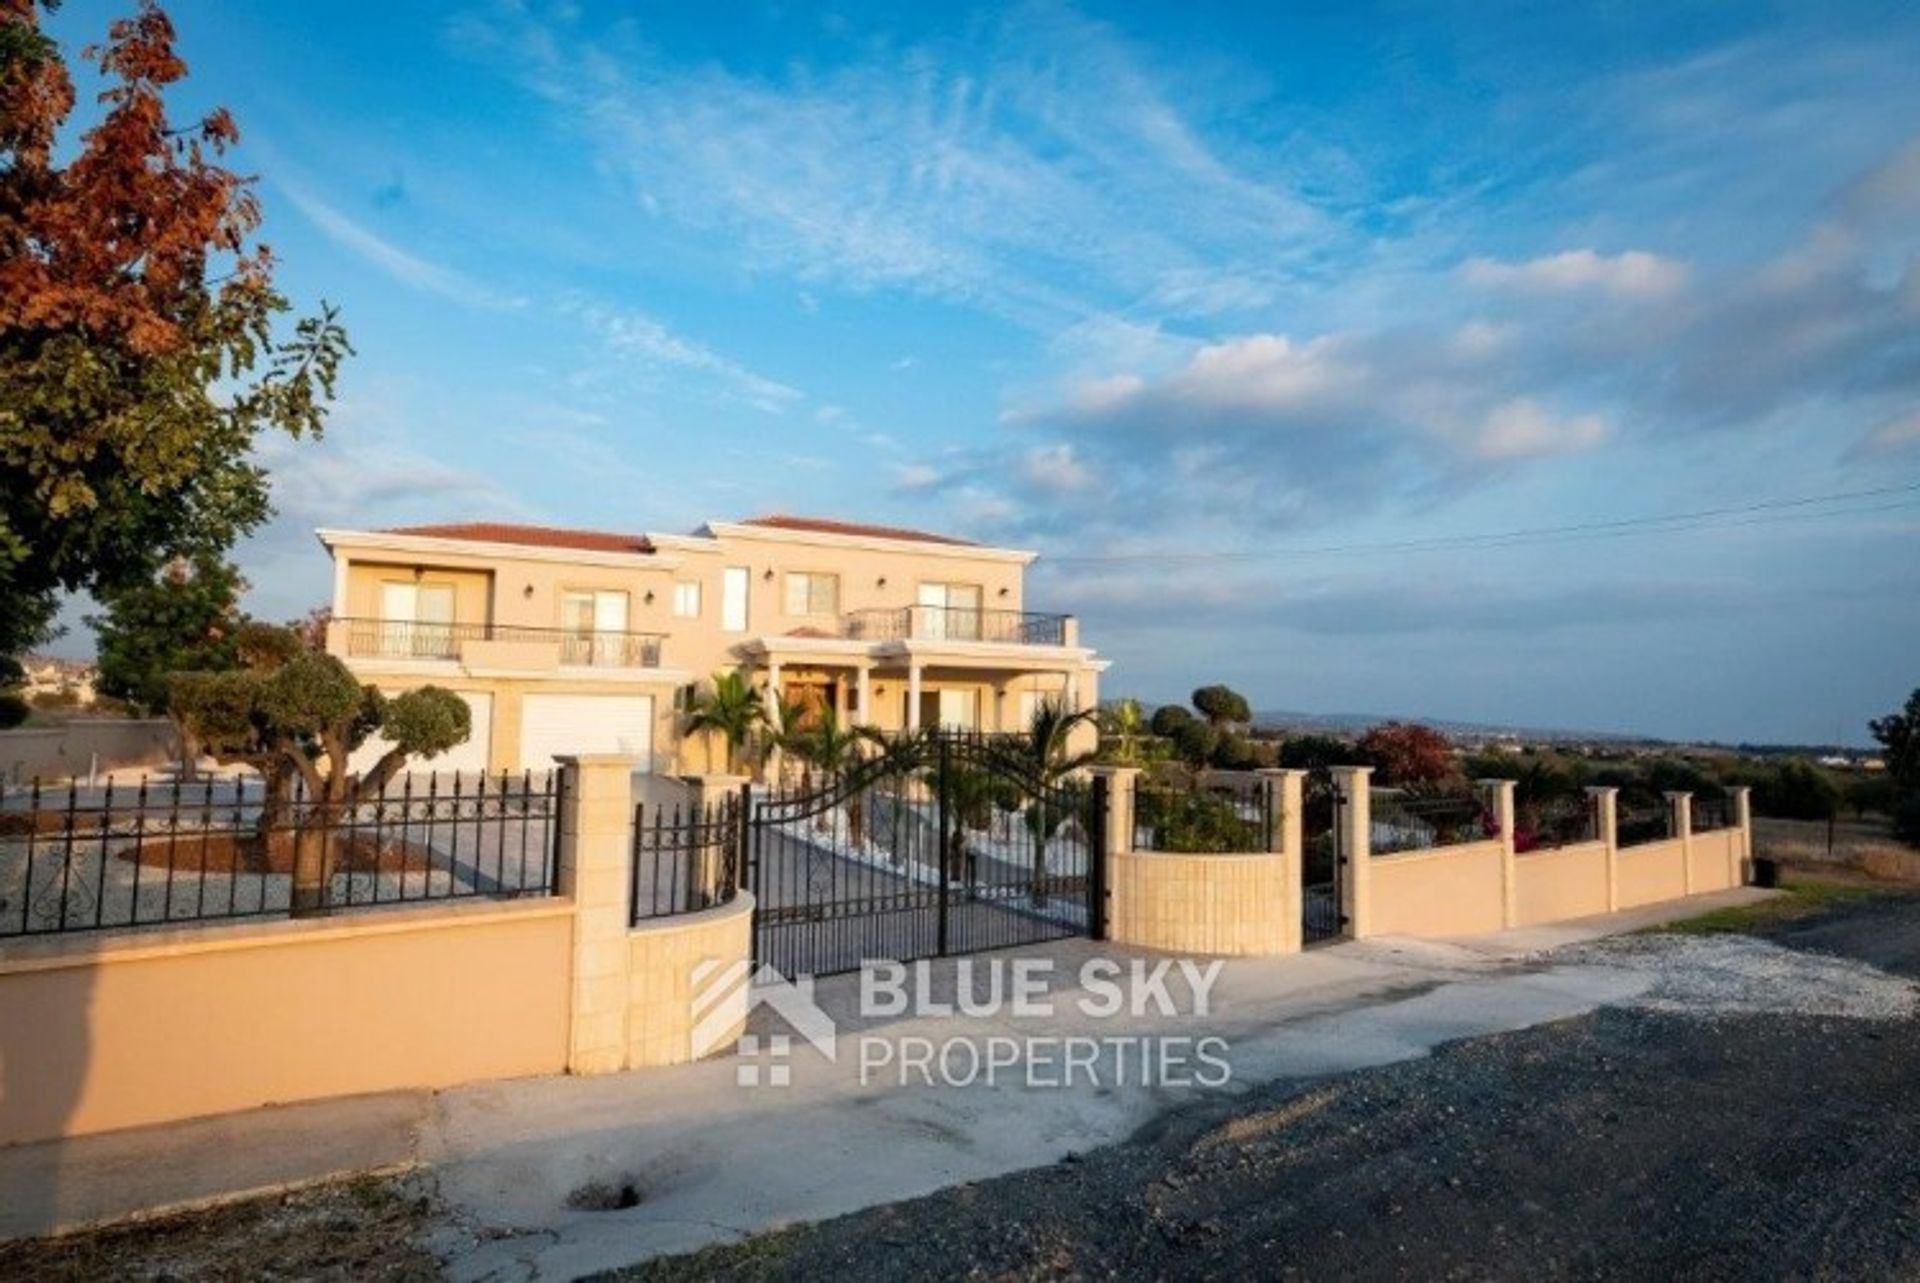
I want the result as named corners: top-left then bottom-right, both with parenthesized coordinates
top-left (41, 0), bottom-right (1920, 741)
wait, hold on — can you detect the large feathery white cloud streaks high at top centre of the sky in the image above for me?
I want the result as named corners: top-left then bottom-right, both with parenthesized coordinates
top-left (459, 10), bottom-right (1340, 328)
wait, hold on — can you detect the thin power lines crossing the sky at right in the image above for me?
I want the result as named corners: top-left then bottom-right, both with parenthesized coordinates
top-left (1046, 482), bottom-right (1920, 565)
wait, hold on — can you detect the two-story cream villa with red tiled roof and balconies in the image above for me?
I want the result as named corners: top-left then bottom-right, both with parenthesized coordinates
top-left (319, 517), bottom-right (1108, 772)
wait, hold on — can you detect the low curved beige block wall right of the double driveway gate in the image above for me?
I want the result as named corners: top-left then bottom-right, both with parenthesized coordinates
top-left (1106, 851), bottom-right (1298, 956)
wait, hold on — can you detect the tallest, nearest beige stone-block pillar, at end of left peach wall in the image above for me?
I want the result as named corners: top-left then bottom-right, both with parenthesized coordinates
top-left (555, 753), bottom-right (636, 1074)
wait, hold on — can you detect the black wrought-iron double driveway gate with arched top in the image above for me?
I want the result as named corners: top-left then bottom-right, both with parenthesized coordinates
top-left (745, 732), bottom-right (1106, 976)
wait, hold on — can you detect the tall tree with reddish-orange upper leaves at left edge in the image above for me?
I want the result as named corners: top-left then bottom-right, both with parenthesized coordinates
top-left (0, 0), bottom-right (351, 653)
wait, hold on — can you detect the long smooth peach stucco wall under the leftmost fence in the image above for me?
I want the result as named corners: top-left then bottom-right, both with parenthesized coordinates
top-left (0, 901), bottom-right (572, 1143)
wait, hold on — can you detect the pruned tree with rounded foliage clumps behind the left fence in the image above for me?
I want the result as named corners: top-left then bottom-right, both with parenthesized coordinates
top-left (173, 624), bottom-right (472, 914)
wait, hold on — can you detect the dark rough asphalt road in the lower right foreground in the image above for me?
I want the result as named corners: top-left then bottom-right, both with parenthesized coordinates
top-left (620, 897), bottom-right (1920, 1279)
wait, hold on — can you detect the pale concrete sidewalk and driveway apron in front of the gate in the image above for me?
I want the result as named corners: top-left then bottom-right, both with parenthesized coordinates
top-left (0, 889), bottom-right (1770, 1279)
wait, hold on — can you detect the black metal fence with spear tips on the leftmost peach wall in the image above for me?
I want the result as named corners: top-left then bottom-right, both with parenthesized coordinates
top-left (0, 772), bottom-right (561, 937)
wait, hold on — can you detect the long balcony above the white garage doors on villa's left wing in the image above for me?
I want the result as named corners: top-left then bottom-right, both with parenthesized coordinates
top-left (341, 618), bottom-right (662, 670)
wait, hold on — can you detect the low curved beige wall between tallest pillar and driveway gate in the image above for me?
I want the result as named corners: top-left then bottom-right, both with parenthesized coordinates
top-left (626, 891), bottom-right (753, 1070)
